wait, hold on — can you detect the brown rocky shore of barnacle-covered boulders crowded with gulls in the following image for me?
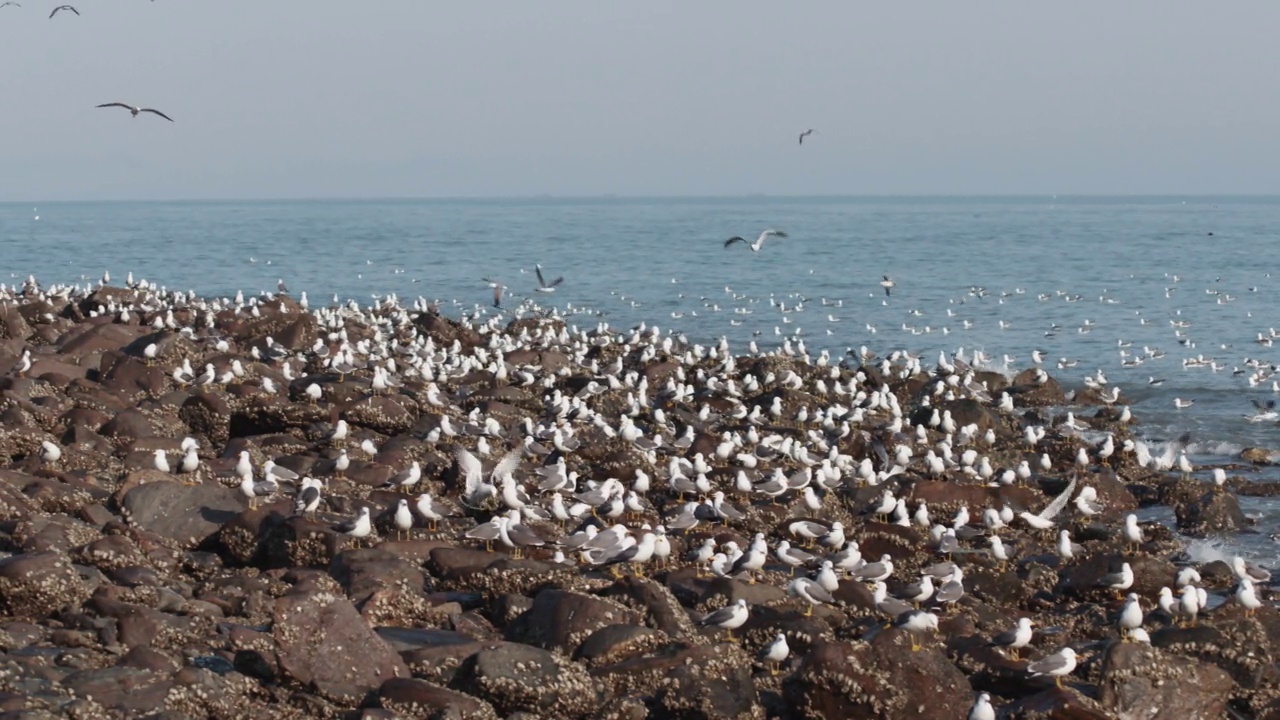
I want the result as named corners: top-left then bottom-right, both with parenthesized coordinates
top-left (0, 282), bottom-right (1280, 720)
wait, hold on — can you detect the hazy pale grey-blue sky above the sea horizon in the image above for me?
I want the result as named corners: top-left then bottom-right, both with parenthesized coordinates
top-left (0, 0), bottom-right (1280, 201)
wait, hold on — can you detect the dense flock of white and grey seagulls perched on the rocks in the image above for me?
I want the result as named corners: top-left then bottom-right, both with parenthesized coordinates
top-left (0, 253), bottom-right (1270, 717)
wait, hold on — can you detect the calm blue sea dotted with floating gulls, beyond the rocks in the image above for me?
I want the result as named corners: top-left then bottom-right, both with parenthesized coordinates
top-left (0, 197), bottom-right (1280, 553)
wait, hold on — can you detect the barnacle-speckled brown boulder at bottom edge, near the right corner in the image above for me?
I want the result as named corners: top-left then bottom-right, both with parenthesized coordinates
top-left (1098, 643), bottom-right (1234, 720)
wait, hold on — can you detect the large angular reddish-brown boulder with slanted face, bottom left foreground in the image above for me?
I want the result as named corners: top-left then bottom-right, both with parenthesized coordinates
top-left (271, 591), bottom-right (408, 697)
